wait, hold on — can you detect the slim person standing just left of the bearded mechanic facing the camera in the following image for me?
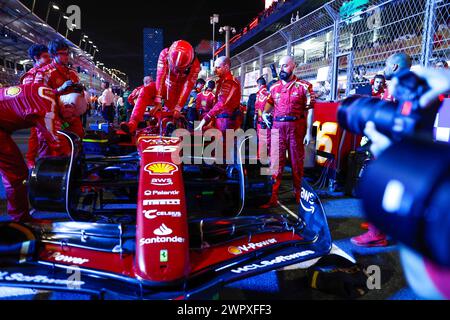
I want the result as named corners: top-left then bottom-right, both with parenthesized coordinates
top-left (254, 77), bottom-right (270, 156)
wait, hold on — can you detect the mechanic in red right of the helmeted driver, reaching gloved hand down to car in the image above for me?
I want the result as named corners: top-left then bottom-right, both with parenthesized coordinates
top-left (195, 57), bottom-right (241, 137)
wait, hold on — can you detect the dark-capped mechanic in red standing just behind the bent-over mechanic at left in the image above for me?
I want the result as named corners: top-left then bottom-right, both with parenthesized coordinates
top-left (26, 40), bottom-right (84, 167)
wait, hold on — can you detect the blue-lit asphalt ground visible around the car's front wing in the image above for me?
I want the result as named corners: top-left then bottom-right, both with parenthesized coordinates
top-left (0, 118), bottom-right (419, 300)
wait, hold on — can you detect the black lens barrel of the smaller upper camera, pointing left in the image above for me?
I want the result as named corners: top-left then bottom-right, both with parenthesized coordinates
top-left (337, 96), bottom-right (398, 137)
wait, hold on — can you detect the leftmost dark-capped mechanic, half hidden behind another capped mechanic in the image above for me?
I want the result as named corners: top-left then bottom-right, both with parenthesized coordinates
top-left (20, 44), bottom-right (52, 168)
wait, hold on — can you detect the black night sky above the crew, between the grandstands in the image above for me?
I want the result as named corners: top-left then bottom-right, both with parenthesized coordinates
top-left (27, 0), bottom-right (264, 86)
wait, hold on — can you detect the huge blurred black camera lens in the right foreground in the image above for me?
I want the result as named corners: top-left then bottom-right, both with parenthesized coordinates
top-left (360, 139), bottom-right (450, 267)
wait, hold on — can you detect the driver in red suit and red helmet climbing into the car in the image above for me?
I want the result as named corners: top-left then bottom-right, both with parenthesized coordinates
top-left (121, 40), bottom-right (200, 132)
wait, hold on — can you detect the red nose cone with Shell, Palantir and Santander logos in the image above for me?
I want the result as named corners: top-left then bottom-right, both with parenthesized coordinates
top-left (136, 135), bottom-right (189, 282)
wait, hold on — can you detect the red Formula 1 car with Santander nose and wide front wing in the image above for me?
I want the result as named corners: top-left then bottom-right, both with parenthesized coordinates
top-left (0, 112), bottom-right (332, 299)
